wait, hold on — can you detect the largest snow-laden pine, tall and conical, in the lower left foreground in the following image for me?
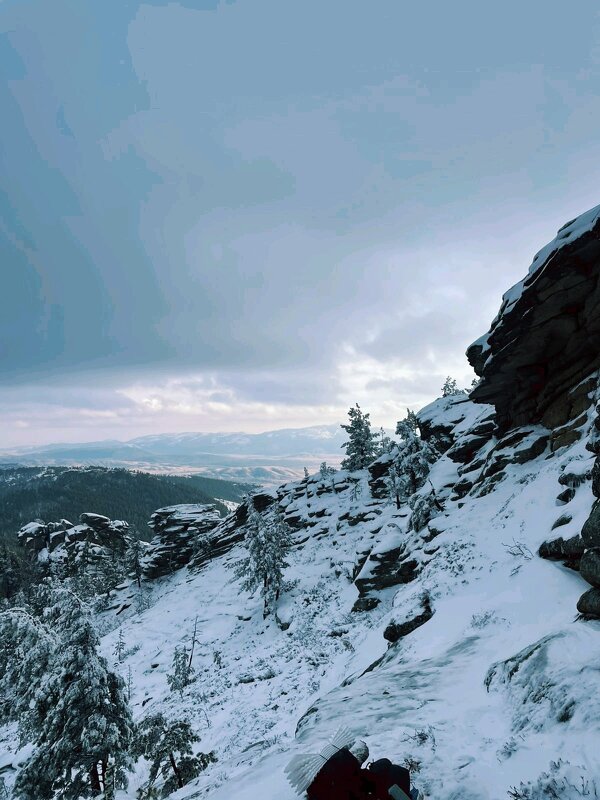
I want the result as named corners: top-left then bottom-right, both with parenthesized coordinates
top-left (14, 589), bottom-right (133, 800)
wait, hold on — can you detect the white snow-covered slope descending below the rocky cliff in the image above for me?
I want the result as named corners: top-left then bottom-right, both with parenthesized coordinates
top-left (0, 400), bottom-right (600, 800)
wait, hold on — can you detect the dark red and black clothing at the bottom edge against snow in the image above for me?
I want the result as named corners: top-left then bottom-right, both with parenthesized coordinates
top-left (307, 750), bottom-right (410, 800)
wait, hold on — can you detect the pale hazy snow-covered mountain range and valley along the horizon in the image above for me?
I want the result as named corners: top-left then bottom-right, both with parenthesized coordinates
top-left (0, 425), bottom-right (347, 484)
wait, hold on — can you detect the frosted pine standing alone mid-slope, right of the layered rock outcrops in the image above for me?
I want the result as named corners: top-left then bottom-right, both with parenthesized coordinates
top-left (235, 498), bottom-right (291, 618)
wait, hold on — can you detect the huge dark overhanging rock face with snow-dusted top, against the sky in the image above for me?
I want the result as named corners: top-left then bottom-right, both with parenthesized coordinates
top-left (467, 207), bottom-right (600, 434)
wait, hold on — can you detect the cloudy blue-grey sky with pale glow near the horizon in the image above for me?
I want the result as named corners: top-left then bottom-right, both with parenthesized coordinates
top-left (0, 0), bottom-right (600, 447)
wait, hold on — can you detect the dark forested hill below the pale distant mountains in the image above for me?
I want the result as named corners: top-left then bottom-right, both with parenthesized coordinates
top-left (0, 467), bottom-right (255, 543)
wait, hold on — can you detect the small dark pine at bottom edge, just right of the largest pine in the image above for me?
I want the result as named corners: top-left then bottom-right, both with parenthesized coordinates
top-left (134, 713), bottom-right (217, 797)
